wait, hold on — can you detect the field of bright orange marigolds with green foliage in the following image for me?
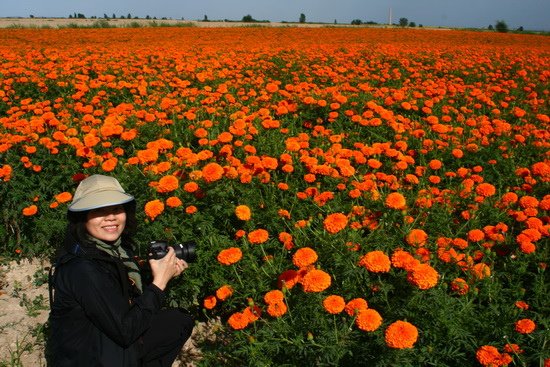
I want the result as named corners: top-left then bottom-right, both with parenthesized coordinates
top-left (0, 27), bottom-right (550, 366)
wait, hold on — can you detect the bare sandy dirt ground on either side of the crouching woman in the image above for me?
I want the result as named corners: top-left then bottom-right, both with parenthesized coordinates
top-left (0, 260), bottom-right (216, 367)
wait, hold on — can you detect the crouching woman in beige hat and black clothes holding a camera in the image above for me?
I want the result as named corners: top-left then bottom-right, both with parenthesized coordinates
top-left (48, 175), bottom-right (193, 367)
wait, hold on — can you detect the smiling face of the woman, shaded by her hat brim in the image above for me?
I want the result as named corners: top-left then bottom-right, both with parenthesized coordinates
top-left (86, 205), bottom-right (126, 242)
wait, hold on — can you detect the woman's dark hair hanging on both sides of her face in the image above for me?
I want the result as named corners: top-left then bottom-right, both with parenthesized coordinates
top-left (63, 200), bottom-right (137, 249)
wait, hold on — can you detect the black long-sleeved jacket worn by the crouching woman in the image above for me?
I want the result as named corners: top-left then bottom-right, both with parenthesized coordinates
top-left (48, 244), bottom-right (164, 367)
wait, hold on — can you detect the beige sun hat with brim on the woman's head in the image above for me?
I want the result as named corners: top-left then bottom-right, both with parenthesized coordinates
top-left (69, 175), bottom-right (134, 212)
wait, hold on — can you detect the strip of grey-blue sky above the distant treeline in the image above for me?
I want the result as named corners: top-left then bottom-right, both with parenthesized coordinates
top-left (0, 0), bottom-right (550, 31)
